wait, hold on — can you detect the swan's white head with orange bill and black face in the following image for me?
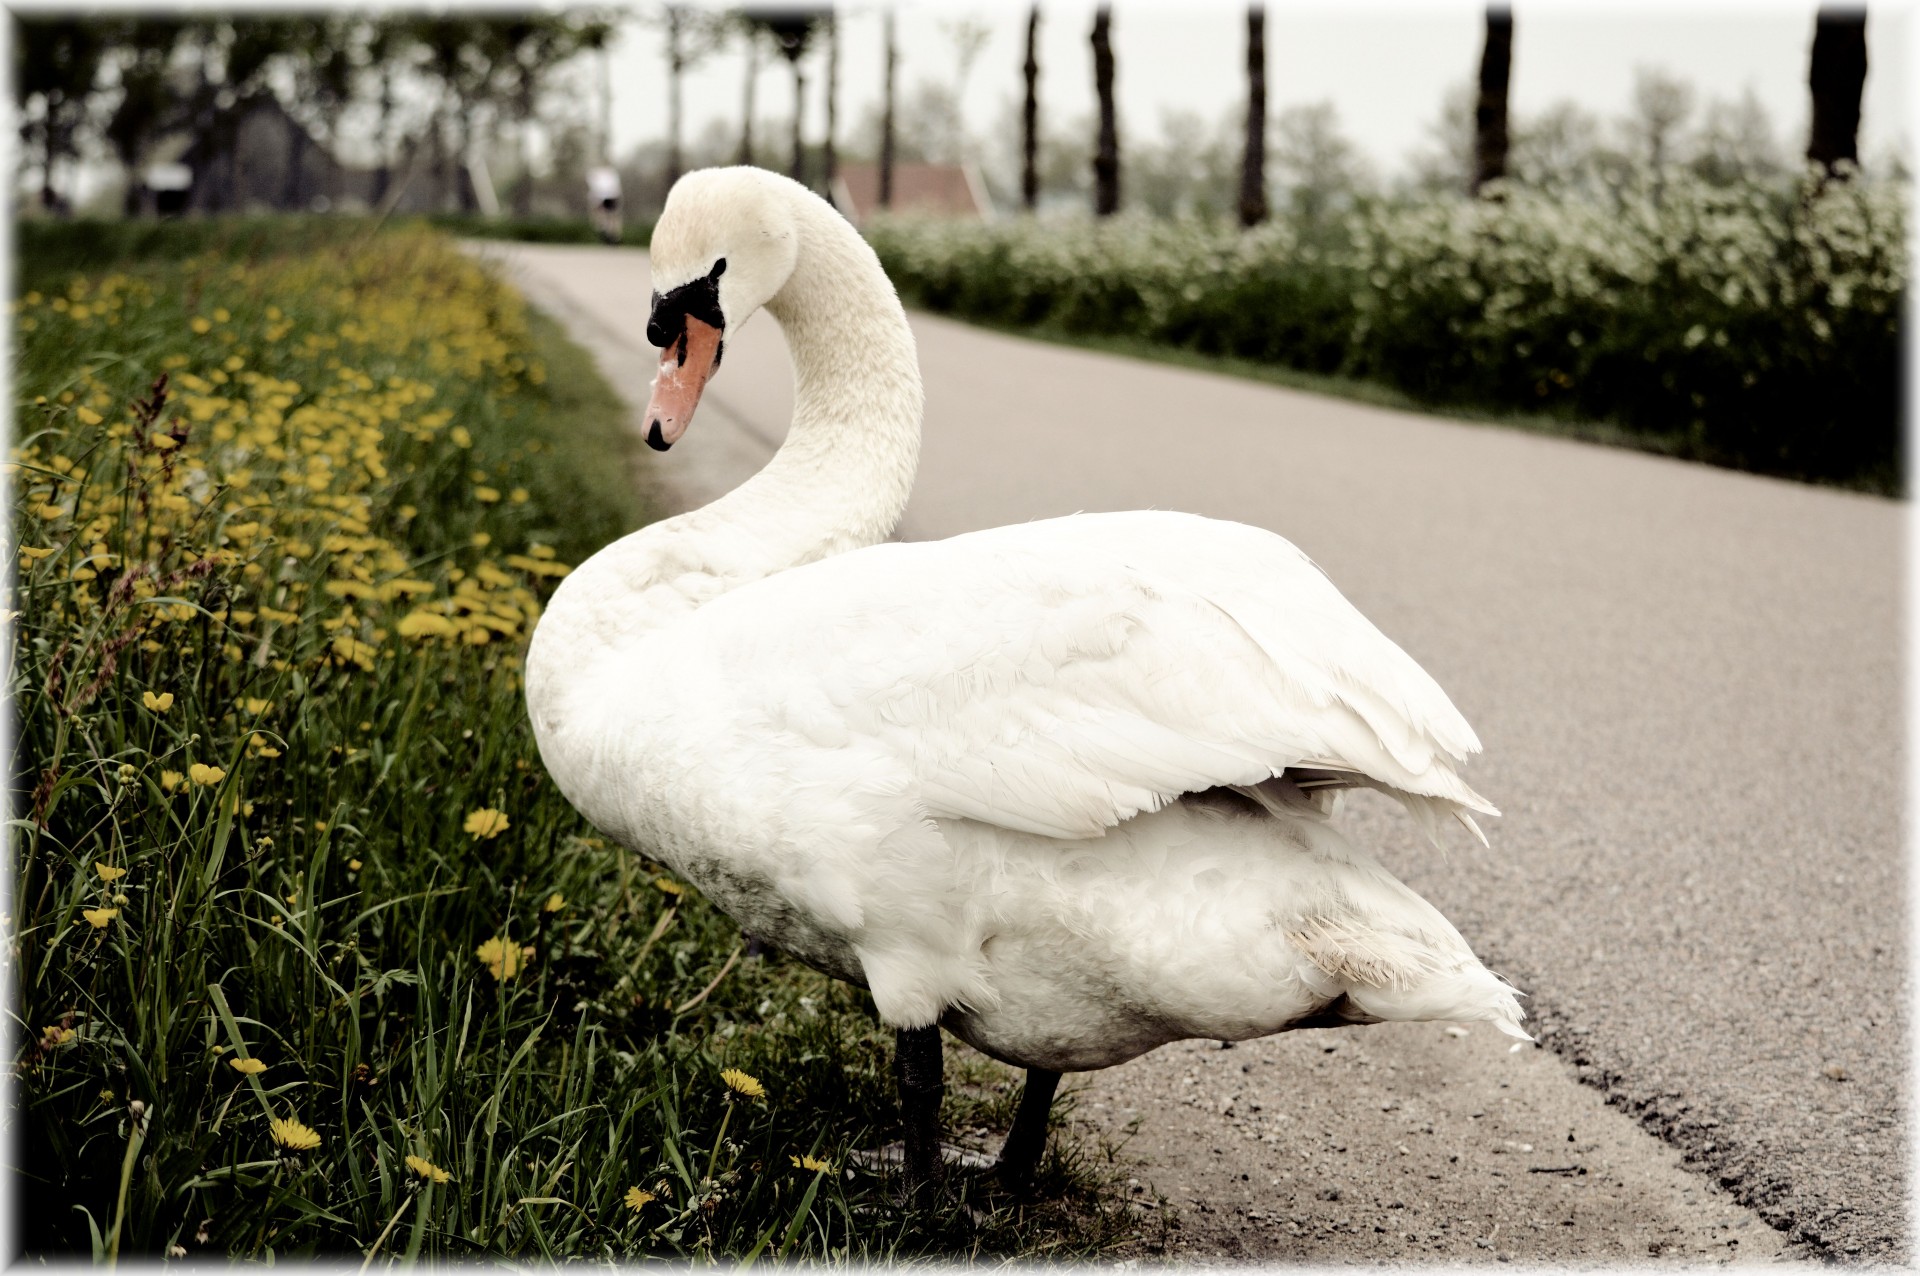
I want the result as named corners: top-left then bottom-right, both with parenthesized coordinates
top-left (647, 169), bottom-right (806, 451)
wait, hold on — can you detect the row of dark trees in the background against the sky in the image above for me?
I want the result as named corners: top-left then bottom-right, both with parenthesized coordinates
top-left (13, 2), bottom-right (1866, 226)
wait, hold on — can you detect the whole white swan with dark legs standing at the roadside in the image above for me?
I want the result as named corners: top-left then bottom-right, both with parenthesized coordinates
top-left (526, 167), bottom-right (1530, 1184)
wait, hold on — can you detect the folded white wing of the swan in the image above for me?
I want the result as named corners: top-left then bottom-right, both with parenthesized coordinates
top-left (682, 514), bottom-right (1492, 837)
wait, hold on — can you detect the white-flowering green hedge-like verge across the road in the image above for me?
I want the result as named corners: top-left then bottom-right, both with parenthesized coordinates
top-left (868, 177), bottom-right (1907, 491)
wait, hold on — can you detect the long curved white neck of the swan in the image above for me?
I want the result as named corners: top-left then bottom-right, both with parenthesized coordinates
top-left (528, 197), bottom-right (922, 675)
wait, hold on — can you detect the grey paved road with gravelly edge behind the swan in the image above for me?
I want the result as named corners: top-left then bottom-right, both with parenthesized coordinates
top-left (483, 249), bottom-right (1910, 1261)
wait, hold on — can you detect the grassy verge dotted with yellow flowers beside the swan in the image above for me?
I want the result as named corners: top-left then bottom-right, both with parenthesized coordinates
top-left (6, 223), bottom-right (1121, 1261)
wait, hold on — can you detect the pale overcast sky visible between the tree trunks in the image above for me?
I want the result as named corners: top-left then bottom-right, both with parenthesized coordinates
top-left (612, 0), bottom-right (1914, 175)
